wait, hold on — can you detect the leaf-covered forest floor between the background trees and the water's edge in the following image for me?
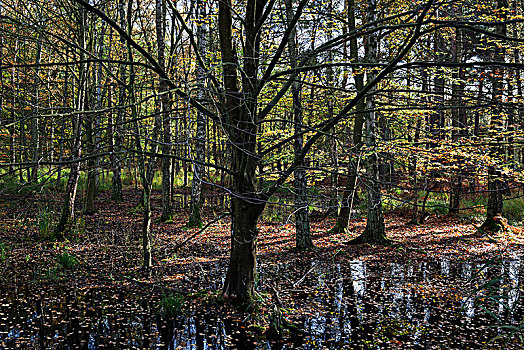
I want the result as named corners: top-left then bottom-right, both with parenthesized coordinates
top-left (0, 190), bottom-right (524, 348)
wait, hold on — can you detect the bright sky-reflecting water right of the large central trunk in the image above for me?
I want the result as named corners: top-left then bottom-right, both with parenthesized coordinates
top-left (298, 258), bottom-right (524, 349)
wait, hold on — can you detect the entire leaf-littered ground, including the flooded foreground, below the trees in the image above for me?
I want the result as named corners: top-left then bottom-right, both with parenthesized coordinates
top-left (0, 192), bottom-right (524, 349)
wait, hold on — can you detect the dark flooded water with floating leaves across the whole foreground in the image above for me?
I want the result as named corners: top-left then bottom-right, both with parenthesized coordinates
top-left (0, 258), bottom-right (524, 349)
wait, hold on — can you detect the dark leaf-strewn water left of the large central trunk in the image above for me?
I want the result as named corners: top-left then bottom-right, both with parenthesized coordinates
top-left (0, 288), bottom-right (242, 349)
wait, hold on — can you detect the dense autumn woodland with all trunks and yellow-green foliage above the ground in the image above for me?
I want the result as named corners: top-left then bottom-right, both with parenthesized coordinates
top-left (0, 0), bottom-right (524, 298)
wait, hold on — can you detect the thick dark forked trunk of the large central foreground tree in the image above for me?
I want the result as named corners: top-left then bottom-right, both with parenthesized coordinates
top-left (218, 0), bottom-right (265, 302)
